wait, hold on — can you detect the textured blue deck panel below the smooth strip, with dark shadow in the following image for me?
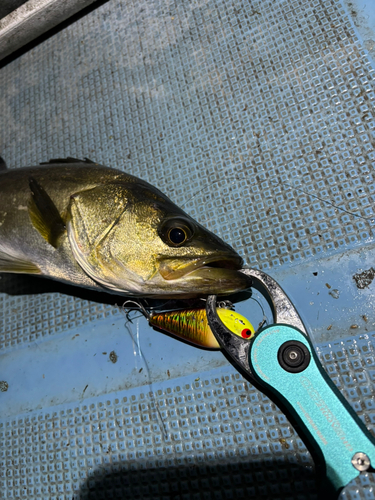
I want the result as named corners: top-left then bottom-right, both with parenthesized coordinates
top-left (0, 334), bottom-right (375, 500)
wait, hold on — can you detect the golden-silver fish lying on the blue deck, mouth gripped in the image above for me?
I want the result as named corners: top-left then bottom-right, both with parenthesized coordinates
top-left (0, 157), bottom-right (251, 299)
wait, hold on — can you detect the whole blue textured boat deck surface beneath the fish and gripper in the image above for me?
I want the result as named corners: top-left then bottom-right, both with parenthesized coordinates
top-left (0, 0), bottom-right (375, 500)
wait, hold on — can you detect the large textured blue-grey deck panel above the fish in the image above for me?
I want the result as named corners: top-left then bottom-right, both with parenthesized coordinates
top-left (0, 1), bottom-right (375, 338)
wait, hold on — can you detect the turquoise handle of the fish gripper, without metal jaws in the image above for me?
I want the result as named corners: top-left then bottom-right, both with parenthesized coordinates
top-left (249, 325), bottom-right (375, 498)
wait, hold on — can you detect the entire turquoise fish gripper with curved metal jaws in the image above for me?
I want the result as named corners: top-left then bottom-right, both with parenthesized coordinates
top-left (206, 269), bottom-right (375, 499)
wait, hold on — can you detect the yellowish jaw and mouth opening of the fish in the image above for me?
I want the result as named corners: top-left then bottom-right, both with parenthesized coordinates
top-left (159, 255), bottom-right (243, 281)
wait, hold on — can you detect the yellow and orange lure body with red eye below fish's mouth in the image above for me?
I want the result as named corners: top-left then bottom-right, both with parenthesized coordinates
top-left (149, 308), bottom-right (255, 349)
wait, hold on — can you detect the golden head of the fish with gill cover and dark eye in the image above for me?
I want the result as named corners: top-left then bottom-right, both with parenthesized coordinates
top-left (67, 180), bottom-right (250, 298)
